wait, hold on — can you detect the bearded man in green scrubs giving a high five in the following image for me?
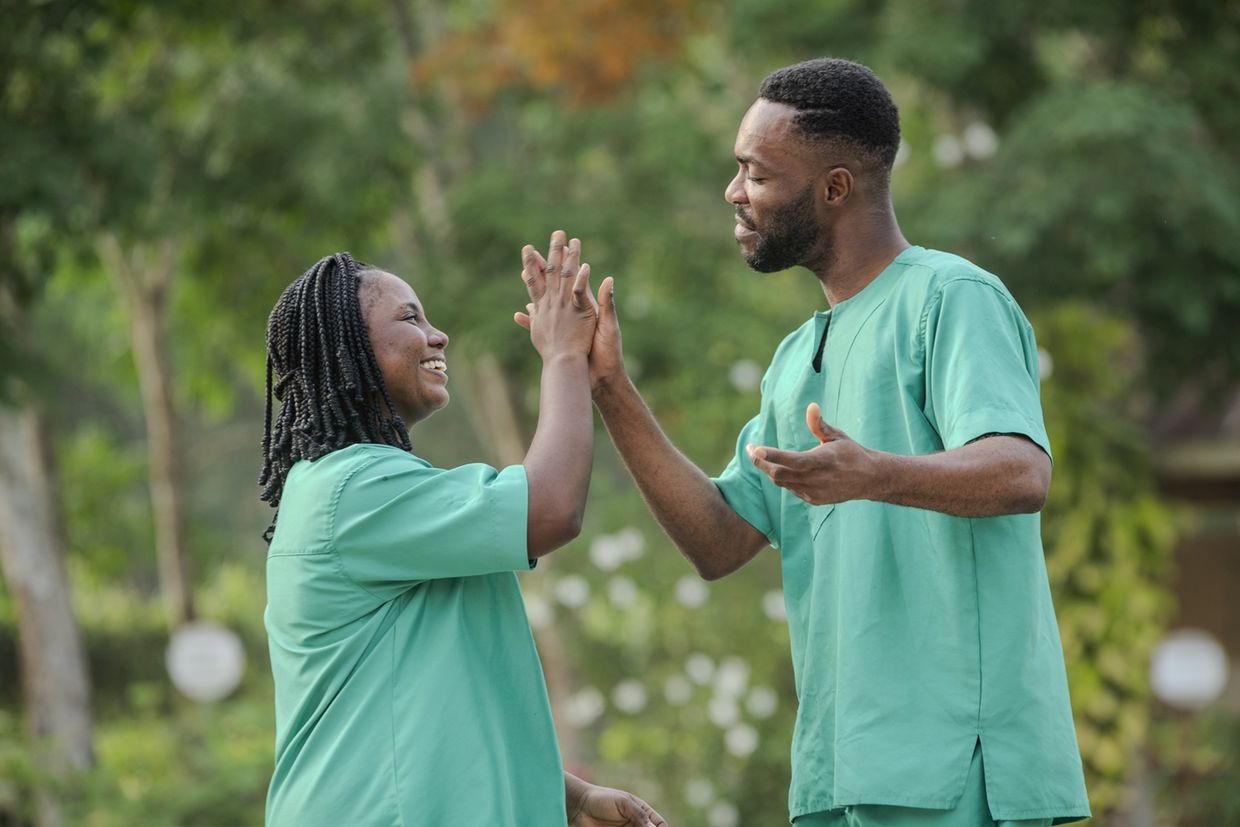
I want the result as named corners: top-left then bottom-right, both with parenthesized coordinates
top-left (577, 60), bottom-right (1089, 827)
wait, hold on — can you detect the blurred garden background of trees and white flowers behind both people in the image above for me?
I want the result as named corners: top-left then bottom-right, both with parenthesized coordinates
top-left (0, 0), bottom-right (1240, 827)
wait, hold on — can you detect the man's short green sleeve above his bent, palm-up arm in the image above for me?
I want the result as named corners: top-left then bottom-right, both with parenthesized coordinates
top-left (923, 279), bottom-right (1050, 456)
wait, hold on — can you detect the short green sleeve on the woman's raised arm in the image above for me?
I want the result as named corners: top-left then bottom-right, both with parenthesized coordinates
top-left (332, 451), bottom-right (531, 596)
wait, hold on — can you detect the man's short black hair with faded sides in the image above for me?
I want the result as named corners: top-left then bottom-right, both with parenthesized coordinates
top-left (758, 57), bottom-right (900, 172)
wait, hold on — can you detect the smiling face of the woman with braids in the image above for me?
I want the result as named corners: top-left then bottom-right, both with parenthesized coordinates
top-left (358, 270), bottom-right (448, 428)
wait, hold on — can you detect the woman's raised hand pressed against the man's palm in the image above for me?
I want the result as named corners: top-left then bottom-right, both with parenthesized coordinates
top-left (515, 229), bottom-right (598, 361)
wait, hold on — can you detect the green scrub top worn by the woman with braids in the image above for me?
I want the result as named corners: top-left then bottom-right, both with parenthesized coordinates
top-left (265, 444), bottom-right (567, 827)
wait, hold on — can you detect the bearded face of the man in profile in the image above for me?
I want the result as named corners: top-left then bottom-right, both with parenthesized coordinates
top-left (724, 98), bottom-right (830, 273)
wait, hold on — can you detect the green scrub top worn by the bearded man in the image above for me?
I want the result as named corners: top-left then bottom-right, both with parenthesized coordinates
top-left (715, 247), bottom-right (1090, 823)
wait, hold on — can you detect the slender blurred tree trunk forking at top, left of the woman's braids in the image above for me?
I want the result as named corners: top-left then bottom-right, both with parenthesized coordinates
top-left (99, 236), bottom-right (193, 631)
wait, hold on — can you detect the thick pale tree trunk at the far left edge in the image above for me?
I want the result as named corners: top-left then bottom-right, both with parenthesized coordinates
top-left (0, 407), bottom-right (94, 827)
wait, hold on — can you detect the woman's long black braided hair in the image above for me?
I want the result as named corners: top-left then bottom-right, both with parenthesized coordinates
top-left (258, 253), bottom-right (412, 543)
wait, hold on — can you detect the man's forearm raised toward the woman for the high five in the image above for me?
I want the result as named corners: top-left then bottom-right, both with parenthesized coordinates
top-left (594, 376), bottom-right (766, 580)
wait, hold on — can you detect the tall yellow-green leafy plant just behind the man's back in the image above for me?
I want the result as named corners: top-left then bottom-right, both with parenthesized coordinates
top-left (1037, 304), bottom-right (1177, 815)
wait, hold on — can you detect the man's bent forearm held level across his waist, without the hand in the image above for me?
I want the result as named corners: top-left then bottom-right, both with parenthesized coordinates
top-left (873, 435), bottom-right (1050, 517)
